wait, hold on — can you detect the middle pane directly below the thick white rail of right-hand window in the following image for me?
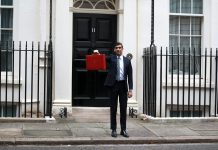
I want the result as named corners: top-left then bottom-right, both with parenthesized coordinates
top-left (180, 17), bottom-right (190, 35)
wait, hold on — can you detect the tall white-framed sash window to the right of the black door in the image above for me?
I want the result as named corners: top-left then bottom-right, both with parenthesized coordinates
top-left (169, 0), bottom-right (203, 75)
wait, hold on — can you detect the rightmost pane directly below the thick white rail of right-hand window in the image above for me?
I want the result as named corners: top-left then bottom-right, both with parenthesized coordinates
top-left (191, 17), bottom-right (201, 35)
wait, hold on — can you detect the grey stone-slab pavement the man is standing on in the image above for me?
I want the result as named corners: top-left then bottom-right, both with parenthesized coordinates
top-left (0, 115), bottom-right (218, 145)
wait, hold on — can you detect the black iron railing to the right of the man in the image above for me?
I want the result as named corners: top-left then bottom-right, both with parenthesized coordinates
top-left (143, 47), bottom-right (218, 117)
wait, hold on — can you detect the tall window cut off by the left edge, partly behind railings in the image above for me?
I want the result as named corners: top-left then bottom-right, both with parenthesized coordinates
top-left (0, 0), bottom-right (13, 71)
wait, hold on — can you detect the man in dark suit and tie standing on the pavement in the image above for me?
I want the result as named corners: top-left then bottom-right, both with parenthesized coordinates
top-left (104, 42), bottom-right (133, 137)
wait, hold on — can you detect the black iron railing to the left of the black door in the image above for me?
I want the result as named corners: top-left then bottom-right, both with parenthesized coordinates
top-left (0, 42), bottom-right (53, 118)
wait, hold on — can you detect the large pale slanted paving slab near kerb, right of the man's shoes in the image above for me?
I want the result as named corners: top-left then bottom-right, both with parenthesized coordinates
top-left (146, 125), bottom-right (199, 136)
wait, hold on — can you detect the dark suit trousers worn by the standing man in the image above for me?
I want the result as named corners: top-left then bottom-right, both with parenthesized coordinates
top-left (110, 81), bottom-right (127, 130)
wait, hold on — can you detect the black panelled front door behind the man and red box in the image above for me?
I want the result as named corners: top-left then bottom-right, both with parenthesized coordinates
top-left (72, 13), bottom-right (117, 107)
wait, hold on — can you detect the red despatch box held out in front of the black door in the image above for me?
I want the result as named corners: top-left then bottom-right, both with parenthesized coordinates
top-left (86, 54), bottom-right (106, 70)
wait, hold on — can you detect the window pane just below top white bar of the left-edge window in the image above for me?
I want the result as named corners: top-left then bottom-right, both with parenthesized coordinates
top-left (1, 9), bottom-right (13, 28)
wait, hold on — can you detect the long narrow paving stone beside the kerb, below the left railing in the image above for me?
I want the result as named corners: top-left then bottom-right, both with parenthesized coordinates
top-left (23, 130), bottom-right (72, 137)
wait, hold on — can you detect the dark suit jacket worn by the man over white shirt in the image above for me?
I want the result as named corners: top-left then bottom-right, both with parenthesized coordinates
top-left (104, 55), bottom-right (133, 91)
